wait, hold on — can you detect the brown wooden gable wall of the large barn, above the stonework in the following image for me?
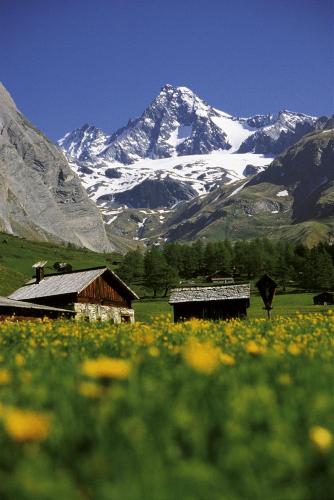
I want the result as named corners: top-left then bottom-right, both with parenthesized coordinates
top-left (77, 276), bottom-right (131, 308)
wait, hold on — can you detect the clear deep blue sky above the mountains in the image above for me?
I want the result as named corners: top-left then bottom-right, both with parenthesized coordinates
top-left (0, 0), bottom-right (334, 140)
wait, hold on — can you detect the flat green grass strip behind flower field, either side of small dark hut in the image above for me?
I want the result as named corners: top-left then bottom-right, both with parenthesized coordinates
top-left (133, 293), bottom-right (331, 323)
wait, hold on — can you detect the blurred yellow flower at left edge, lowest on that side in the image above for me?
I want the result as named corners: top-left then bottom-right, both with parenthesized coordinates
top-left (4, 409), bottom-right (50, 442)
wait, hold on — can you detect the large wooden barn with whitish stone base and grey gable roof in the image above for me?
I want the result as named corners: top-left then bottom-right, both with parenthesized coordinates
top-left (9, 266), bottom-right (139, 323)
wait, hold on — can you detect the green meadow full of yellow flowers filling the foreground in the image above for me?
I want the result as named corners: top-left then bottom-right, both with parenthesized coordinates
top-left (0, 311), bottom-right (334, 500)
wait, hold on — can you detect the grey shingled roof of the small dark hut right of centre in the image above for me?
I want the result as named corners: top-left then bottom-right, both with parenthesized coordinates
top-left (169, 284), bottom-right (250, 304)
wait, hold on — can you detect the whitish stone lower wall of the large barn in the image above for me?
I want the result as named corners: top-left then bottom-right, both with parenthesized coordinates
top-left (74, 302), bottom-right (135, 325)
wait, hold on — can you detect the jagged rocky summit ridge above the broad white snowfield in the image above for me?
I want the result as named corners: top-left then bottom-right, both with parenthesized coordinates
top-left (59, 85), bottom-right (316, 165)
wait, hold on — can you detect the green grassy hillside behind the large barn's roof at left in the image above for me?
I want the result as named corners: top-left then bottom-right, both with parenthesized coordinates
top-left (0, 233), bottom-right (120, 295)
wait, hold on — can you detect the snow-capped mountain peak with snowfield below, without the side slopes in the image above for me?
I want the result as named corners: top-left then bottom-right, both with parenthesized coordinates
top-left (59, 85), bottom-right (316, 213)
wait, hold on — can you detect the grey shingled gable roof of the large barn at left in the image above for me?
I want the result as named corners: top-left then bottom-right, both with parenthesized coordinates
top-left (9, 267), bottom-right (139, 300)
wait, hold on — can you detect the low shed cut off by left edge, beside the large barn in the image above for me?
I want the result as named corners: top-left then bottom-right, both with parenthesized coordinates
top-left (0, 297), bottom-right (75, 321)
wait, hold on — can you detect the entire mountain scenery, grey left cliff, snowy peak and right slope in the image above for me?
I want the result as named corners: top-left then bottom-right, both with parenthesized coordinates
top-left (0, 84), bottom-right (334, 252)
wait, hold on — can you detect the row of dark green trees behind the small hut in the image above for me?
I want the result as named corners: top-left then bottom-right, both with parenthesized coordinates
top-left (118, 238), bottom-right (334, 296)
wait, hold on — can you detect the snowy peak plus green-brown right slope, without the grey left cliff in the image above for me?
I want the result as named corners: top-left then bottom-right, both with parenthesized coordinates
top-left (59, 85), bottom-right (334, 250)
